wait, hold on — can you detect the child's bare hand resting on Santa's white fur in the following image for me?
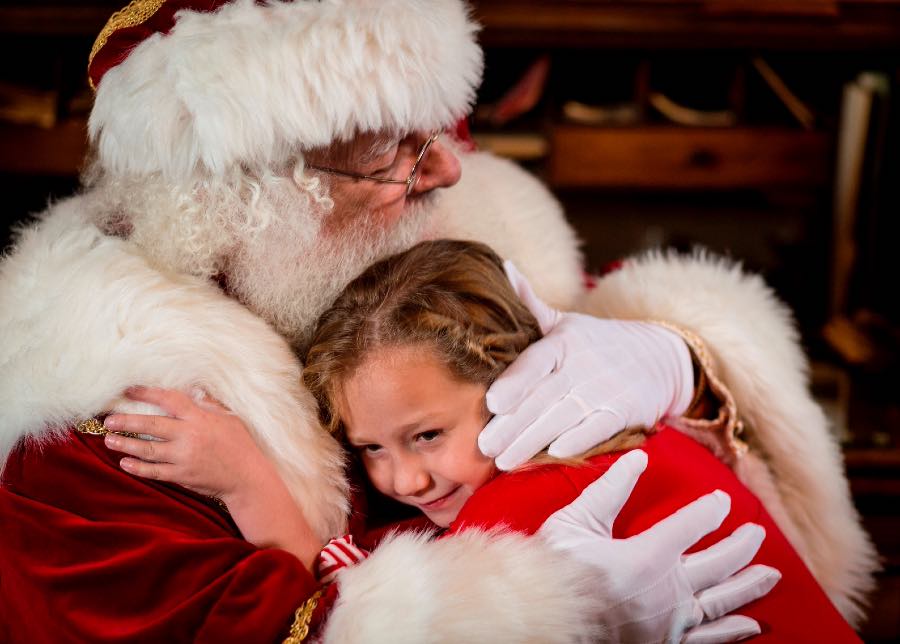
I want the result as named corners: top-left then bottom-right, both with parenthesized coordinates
top-left (104, 387), bottom-right (274, 505)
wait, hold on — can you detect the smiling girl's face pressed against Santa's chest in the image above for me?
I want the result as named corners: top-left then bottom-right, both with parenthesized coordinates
top-left (339, 345), bottom-right (495, 527)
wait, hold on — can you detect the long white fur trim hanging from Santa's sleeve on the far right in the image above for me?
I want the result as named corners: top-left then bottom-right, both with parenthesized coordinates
top-left (583, 253), bottom-right (877, 624)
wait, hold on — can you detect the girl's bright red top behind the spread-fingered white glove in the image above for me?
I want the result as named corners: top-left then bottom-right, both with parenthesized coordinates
top-left (451, 429), bottom-right (859, 642)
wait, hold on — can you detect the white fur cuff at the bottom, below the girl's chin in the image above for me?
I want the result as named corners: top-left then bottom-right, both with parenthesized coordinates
top-left (324, 530), bottom-right (602, 644)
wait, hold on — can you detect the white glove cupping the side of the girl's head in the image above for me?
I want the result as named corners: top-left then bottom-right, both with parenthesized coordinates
top-left (478, 261), bottom-right (694, 470)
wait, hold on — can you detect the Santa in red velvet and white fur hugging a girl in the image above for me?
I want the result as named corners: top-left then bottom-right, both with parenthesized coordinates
top-left (0, 0), bottom-right (875, 642)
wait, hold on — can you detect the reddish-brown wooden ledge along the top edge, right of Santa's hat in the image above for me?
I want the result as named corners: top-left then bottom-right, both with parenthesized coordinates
top-left (474, 0), bottom-right (900, 52)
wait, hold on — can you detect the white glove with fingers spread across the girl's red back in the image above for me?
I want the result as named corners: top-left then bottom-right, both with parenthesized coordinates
top-left (538, 450), bottom-right (781, 644)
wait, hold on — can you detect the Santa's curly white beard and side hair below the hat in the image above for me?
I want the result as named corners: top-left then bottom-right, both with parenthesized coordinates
top-left (88, 164), bottom-right (437, 350)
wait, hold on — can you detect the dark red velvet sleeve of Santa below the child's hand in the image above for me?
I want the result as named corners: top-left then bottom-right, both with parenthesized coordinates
top-left (0, 433), bottom-right (317, 643)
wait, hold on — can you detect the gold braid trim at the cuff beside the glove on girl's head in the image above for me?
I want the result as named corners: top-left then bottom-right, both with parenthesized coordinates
top-left (650, 320), bottom-right (748, 458)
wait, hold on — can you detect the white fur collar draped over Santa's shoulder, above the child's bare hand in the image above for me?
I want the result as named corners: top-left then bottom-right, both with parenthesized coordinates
top-left (0, 197), bottom-right (347, 538)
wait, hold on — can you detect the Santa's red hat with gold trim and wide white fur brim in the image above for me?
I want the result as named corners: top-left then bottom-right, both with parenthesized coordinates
top-left (89, 0), bottom-right (482, 180)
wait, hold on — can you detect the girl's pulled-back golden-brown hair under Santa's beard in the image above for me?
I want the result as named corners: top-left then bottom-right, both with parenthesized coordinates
top-left (303, 240), bottom-right (648, 461)
